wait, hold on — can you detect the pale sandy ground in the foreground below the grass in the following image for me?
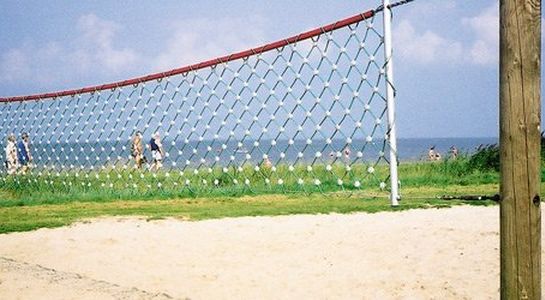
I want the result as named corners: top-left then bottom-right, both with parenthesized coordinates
top-left (0, 206), bottom-right (545, 299)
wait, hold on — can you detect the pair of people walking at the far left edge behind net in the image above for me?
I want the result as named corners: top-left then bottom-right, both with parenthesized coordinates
top-left (4, 132), bottom-right (32, 175)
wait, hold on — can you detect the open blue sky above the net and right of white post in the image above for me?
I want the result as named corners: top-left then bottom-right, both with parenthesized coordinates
top-left (0, 0), bottom-right (543, 138)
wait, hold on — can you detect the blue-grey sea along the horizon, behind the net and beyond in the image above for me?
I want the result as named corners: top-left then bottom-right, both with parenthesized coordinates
top-left (15, 137), bottom-right (498, 169)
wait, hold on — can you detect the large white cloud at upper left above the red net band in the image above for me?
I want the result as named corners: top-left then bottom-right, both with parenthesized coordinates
top-left (0, 14), bottom-right (140, 88)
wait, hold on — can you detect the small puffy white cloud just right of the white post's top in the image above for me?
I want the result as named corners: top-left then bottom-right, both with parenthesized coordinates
top-left (394, 20), bottom-right (463, 64)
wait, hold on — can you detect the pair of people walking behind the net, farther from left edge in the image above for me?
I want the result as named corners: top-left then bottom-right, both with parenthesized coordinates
top-left (131, 131), bottom-right (165, 171)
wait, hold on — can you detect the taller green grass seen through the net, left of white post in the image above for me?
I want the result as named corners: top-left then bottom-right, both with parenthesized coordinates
top-left (0, 164), bottom-right (388, 207)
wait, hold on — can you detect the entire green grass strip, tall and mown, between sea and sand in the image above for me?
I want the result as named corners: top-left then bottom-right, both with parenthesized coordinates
top-left (0, 158), bottom-right (520, 233)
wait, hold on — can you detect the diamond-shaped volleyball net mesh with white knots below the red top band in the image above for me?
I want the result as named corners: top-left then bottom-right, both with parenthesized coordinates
top-left (0, 7), bottom-right (396, 197)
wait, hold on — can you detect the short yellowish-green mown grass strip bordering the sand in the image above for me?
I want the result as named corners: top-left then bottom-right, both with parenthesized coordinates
top-left (0, 194), bottom-right (493, 233)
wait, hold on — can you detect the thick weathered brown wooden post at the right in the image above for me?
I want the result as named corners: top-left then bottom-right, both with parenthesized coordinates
top-left (500, 0), bottom-right (541, 299)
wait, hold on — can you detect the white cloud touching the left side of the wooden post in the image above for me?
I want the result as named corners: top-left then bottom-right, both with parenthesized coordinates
top-left (462, 2), bottom-right (500, 65)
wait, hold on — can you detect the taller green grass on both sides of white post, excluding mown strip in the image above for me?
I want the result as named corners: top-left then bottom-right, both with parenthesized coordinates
top-left (0, 157), bottom-right (499, 207)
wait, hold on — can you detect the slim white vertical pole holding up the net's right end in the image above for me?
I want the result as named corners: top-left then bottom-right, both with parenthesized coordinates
top-left (382, 0), bottom-right (399, 206)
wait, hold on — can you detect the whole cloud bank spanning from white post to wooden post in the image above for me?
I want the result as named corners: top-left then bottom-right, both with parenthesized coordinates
top-left (388, 0), bottom-right (499, 65)
